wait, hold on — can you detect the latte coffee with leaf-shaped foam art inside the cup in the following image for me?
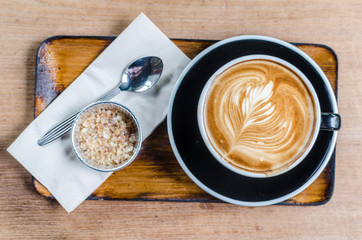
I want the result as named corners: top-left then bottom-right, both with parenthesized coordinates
top-left (202, 59), bottom-right (317, 174)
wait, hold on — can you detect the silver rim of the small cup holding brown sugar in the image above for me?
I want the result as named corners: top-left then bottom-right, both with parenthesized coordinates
top-left (70, 101), bottom-right (142, 172)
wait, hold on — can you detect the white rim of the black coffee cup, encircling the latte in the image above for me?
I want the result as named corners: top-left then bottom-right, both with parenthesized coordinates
top-left (197, 54), bottom-right (321, 178)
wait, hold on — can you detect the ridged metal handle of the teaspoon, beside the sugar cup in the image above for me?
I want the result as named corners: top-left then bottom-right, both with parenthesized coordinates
top-left (38, 87), bottom-right (121, 146)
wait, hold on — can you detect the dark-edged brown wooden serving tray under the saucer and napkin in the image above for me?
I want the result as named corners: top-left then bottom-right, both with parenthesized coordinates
top-left (33, 36), bottom-right (337, 205)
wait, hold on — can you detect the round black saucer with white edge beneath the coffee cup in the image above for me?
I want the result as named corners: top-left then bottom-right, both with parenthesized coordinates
top-left (168, 36), bottom-right (337, 206)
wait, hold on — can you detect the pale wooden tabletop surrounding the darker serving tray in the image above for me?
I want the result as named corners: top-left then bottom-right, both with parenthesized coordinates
top-left (0, 0), bottom-right (362, 239)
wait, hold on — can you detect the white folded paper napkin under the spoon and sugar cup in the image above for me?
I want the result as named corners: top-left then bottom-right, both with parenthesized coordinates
top-left (8, 14), bottom-right (190, 212)
